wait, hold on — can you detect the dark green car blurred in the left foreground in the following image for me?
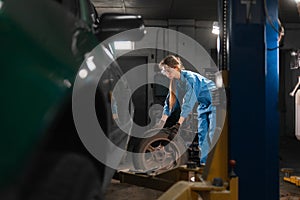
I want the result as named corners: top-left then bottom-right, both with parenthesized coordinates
top-left (0, 0), bottom-right (145, 200)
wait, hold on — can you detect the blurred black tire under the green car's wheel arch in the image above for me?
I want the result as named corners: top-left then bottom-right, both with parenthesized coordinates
top-left (30, 154), bottom-right (103, 200)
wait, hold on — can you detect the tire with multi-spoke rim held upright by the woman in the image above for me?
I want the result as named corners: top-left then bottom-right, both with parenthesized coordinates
top-left (133, 130), bottom-right (188, 171)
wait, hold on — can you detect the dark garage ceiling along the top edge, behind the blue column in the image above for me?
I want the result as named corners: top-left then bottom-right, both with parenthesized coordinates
top-left (92, 0), bottom-right (300, 23)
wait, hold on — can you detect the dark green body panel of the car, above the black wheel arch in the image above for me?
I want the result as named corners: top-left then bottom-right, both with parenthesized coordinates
top-left (0, 0), bottom-right (99, 188)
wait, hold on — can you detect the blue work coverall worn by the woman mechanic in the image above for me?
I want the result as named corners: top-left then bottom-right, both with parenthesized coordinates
top-left (163, 70), bottom-right (216, 164)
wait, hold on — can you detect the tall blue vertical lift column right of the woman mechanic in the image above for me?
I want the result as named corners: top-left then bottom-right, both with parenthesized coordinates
top-left (228, 0), bottom-right (279, 200)
